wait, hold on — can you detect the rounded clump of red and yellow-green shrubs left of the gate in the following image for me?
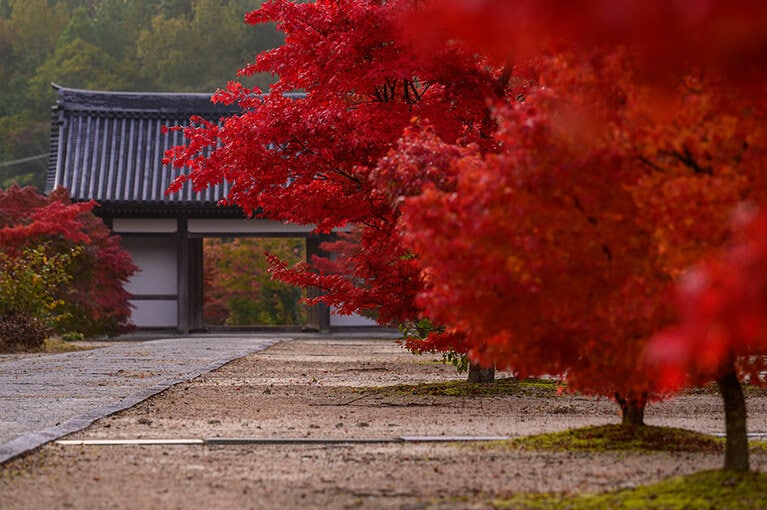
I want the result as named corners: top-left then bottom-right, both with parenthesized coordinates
top-left (0, 186), bottom-right (137, 341)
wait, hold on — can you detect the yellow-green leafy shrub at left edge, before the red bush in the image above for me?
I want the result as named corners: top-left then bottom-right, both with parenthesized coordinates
top-left (0, 245), bottom-right (80, 351)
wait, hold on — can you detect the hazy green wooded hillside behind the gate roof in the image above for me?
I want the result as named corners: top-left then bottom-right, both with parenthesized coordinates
top-left (0, 0), bottom-right (282, 190)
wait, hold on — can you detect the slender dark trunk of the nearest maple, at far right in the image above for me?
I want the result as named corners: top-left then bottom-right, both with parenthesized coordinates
top-left (716, 363), bottom-right (750, 472)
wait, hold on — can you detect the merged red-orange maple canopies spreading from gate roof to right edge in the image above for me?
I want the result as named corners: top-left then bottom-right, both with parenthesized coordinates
top-left (168, 0), bottom-right (767, 438)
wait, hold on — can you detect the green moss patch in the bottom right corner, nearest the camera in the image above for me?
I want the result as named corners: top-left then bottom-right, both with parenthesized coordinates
top-left (490, 470), bottom-right (767, 510)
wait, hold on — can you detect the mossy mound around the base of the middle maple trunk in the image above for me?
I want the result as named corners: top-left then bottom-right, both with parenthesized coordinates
top-left (503, 424), bottom-right (724, 452)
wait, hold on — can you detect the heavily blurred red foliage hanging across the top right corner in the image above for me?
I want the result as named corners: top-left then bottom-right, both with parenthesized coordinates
top-left (409, 0), bottom-right (767, 85)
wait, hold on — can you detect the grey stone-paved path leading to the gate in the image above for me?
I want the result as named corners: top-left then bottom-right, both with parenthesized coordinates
top-left (0, 334), bottom-right (292, 463)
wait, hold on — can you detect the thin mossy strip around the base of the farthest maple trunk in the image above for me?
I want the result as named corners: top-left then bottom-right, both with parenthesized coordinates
top-left (355, 377), bottom-right (559, 397)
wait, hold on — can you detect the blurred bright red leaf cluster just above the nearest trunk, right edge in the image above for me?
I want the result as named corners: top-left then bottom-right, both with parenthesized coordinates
top-left (648, 208), bottom-right (767, 387)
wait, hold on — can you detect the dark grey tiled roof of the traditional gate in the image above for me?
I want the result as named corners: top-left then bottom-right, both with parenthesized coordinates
top-left (46, 86), bottom-right (238, 209)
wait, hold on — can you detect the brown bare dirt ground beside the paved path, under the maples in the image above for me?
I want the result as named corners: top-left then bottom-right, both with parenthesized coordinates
top-left (0, 339), bottom-right (767, 509)
